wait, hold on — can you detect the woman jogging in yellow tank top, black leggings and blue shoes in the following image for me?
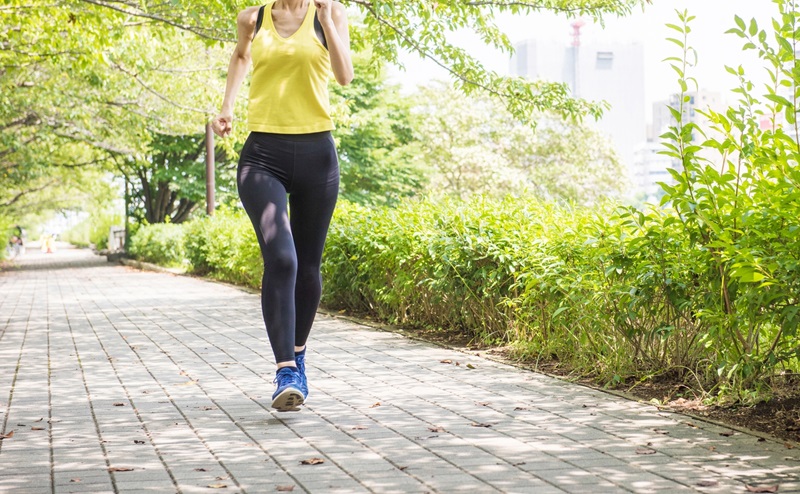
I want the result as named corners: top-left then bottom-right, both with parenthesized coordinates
top-left (212, 0), bottom-right (353, 411)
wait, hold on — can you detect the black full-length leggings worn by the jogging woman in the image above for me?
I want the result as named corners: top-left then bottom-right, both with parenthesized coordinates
top-left (237, 132), bottom-right (339, 363)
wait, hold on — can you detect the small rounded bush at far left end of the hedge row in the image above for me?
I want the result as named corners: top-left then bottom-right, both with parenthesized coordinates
top-left (130, 223), bottom-right (186, 266)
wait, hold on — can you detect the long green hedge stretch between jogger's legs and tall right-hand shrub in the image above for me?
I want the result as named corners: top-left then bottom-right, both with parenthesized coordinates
top-left (323, 197), bottom-right (702, 381)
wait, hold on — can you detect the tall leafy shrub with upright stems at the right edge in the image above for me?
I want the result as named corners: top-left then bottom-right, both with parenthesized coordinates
top-left (663, 6), bottom-right (800, 399)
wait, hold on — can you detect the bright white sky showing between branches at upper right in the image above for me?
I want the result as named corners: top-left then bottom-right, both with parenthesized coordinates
top-left (393, 0), bottom-right (777, 119)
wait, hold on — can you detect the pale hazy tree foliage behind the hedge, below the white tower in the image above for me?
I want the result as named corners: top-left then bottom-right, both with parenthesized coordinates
top-left (412, 83), bottom-right (627, 205)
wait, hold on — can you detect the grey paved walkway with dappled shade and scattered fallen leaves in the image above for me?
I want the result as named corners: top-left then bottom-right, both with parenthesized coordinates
top-left (0, 245), bottom-right (800, 494)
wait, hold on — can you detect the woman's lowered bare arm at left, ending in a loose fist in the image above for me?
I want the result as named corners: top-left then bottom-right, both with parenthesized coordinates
top-left (211, 6), bottom-right (260, 137)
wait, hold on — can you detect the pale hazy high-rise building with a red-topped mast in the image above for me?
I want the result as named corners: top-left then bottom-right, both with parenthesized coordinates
top-left (509, 21), bottom-right (647, 185)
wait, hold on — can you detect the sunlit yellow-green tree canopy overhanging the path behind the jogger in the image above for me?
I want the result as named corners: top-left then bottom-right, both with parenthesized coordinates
top-left (0, 0), bottom-right (647, 224)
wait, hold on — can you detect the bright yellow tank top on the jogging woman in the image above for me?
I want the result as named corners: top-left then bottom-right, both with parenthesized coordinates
top-left (247, 0), bottom-right (334, 134)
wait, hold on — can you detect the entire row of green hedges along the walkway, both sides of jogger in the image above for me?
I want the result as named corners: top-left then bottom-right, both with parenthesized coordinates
top-left (128, 191), bottom-right (797, 400)
